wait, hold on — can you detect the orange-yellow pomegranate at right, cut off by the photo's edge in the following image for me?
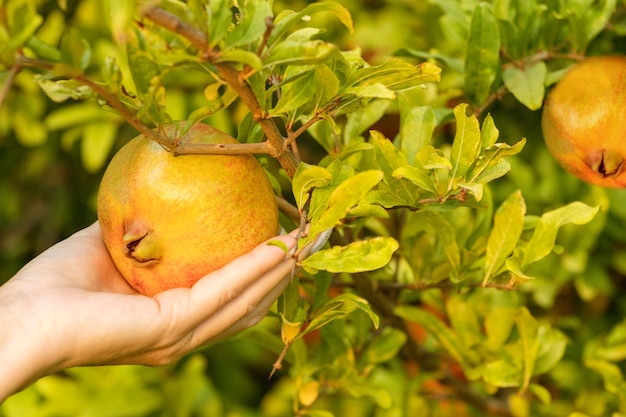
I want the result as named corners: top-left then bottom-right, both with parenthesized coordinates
top-left (541, 56), bottom-right (626, 188)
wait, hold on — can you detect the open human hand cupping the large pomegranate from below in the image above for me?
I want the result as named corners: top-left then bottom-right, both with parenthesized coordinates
top-left (0, 223), bottom-right (296, 402)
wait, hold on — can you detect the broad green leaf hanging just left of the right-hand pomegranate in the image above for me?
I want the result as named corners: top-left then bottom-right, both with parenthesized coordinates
top-left (502, 61), bottom-right (548, 110)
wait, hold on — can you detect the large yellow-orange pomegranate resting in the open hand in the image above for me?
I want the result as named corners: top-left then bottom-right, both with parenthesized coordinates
top-left (98, 124), bottom-right (278, 296)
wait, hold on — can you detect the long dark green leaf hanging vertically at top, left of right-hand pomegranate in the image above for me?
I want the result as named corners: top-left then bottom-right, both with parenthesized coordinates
top-left (465, 2), bottom-right (500, 105)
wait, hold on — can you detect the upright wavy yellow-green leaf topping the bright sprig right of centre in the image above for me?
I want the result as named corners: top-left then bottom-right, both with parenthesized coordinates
top-left (448, 103), bottom-right (481, 190)
